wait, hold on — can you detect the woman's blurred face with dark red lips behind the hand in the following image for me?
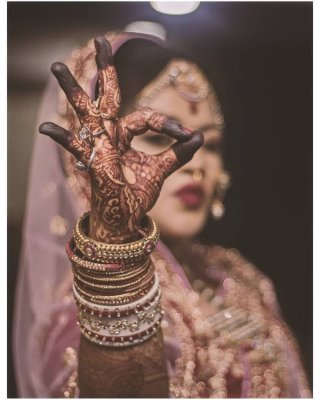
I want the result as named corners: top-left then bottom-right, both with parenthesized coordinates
top-left (132, 87), bottom-right (222, 241)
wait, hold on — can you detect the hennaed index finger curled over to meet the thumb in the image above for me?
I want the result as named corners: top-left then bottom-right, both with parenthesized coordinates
top-left (119, 108), bottom-right (191, 148)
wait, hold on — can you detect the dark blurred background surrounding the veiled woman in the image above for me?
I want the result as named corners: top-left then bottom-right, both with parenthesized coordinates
top-left (7, 2), bottom-right (313, 397)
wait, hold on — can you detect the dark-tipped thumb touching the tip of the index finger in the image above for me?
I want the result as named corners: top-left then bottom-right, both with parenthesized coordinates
top-left (156, 131), bottom-right (204, 177)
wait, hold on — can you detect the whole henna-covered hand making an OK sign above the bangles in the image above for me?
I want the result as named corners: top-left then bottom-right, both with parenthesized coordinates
top-left (39, 37), bottom-right (203, 243)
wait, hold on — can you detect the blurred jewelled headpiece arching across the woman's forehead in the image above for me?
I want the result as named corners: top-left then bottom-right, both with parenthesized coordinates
top-left (134, 59), bottom-right (224, 129)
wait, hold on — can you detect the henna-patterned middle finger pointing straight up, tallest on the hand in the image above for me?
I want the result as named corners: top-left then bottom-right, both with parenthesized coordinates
top-left (94, 36), bottom-right (121, 121)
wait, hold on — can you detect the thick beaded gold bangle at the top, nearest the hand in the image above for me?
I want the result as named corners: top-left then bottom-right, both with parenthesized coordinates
top-left (73, 213), bottom-right (160, 263)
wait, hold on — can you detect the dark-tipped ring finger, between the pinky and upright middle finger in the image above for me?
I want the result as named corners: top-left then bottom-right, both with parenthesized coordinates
top-left (51, 62), bottom-right (93, 118)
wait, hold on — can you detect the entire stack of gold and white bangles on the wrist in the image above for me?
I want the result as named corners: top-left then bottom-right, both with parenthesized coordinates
top-left (66, 213), bottom-right (163, 347)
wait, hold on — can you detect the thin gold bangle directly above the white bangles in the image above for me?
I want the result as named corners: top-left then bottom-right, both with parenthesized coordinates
top-left (73, 279), bottom-right (154, 306)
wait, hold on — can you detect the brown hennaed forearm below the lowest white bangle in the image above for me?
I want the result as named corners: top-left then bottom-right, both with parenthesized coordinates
top-left (79, 329), bottom-right (169, 398)
